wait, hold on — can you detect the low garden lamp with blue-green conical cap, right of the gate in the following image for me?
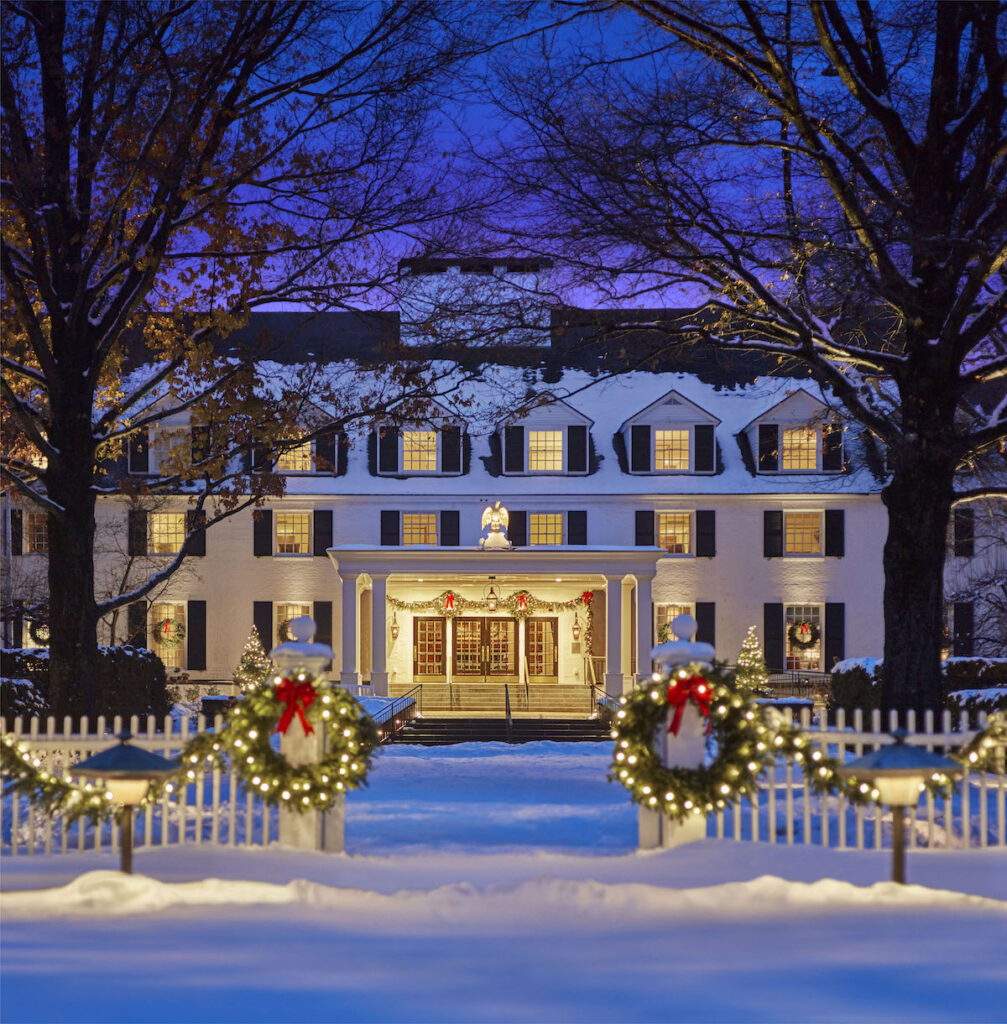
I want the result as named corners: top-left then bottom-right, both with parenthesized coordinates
top-left (836, 729), bottom-right (962, 885)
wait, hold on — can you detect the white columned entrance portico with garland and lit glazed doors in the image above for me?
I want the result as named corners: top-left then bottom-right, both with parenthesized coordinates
top-left (328, 546), bottom-right (664, 696)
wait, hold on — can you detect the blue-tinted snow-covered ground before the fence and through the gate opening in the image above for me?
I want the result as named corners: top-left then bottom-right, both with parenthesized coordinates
top-left (0, 743), bottom-right (1007, 1024)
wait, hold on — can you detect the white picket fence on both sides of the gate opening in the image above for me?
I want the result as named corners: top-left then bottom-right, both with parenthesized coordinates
top-left (0, 709), bottom-right (1007, 855)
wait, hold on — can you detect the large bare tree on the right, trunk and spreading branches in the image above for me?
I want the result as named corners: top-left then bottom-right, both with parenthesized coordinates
top-left (483, 0), bottom-right (1007, 708)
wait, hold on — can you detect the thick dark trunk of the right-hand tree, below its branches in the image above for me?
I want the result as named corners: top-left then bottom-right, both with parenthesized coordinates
top-left (882, 445), bottom-right (955, 725)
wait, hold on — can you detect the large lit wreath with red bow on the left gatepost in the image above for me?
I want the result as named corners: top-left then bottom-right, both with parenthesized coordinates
top-left (175, 672), bottom-right (378, 811)
